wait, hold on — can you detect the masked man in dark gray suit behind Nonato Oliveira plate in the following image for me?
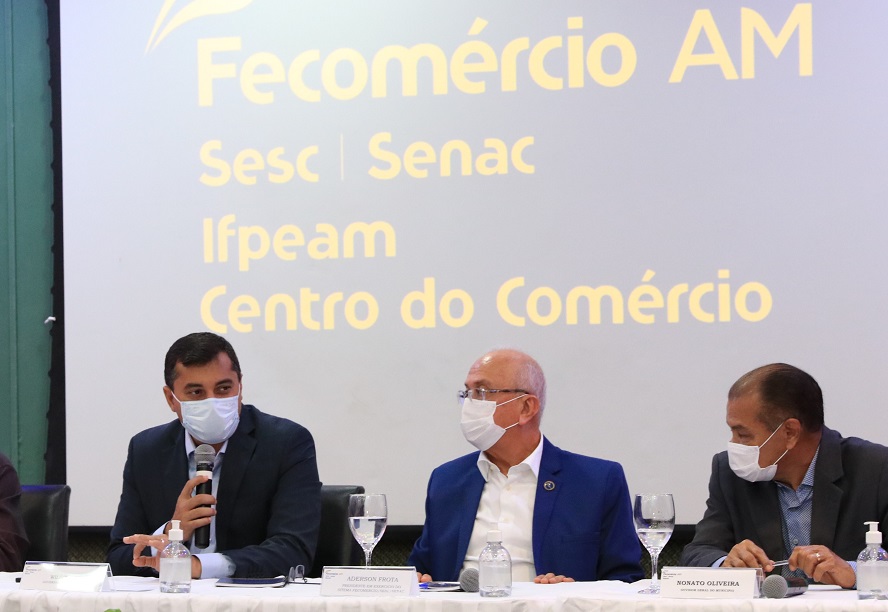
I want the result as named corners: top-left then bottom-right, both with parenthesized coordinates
top-left (681, 363), bottom-right (888, 588)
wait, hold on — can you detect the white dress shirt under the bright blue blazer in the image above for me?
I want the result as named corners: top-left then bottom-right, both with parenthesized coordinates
top-left (463, 436), bottom-right (543, 582)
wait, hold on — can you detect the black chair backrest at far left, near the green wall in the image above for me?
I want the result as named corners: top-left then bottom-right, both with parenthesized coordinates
top-left (21, 485), bottom-right (71, 561)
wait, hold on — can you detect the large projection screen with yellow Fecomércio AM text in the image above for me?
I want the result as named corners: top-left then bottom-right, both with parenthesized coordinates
top-left (61, 0), bottom-right (888, 526)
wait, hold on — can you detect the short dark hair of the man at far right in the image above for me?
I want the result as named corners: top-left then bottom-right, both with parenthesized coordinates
top-left (728, 363), bottom-right (823, 432)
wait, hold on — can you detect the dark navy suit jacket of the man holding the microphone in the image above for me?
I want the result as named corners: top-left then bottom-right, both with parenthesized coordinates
top-left (108, 404), bottom-right (321, 577)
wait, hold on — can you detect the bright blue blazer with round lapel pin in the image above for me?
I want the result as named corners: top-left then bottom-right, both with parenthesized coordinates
top-left (407, 439), bottom-right (642, 581)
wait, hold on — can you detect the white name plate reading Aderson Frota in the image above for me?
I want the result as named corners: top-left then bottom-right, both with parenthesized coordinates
top-left (321, 566), bottom-right (419, 597)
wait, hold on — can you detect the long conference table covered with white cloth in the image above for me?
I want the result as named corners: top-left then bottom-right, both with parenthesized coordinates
top-left (0, 573), bottom-right (888, 612)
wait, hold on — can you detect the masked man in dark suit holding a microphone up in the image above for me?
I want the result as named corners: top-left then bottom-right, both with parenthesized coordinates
top-left (108, 332), bottom-right (321, 578)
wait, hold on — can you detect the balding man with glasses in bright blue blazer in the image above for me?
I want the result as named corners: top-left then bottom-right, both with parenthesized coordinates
top-left (408, 350), bottom-right (643, 582)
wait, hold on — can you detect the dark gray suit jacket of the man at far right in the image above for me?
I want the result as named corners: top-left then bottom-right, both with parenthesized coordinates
top-left (681, 427), bottom-right (888, 566)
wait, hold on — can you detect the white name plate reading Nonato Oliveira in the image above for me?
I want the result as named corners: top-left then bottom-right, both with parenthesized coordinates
top-left (660, 567), bottom-right (763, 599)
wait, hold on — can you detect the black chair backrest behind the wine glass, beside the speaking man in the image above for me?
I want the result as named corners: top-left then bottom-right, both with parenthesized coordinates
top-left (306, 485), bottom-right (364, 578)
